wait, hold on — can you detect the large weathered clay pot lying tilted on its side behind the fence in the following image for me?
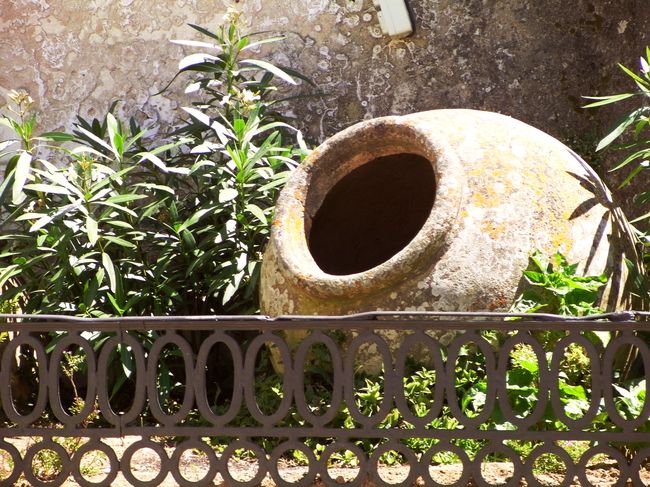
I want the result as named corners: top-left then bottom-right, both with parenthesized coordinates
top-left (261, 110), bottom-right (633, 326)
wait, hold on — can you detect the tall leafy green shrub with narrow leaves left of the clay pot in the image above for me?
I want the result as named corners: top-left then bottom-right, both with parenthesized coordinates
top-left (0, 12), bottom-right (306, 316)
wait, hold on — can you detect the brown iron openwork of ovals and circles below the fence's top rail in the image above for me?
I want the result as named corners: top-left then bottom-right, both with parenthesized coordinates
top-left (0, 319), bottom-right (650, 487)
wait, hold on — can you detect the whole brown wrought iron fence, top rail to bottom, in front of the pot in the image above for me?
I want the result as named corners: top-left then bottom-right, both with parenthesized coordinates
top-left (0, 313), bottom-right (650, 486)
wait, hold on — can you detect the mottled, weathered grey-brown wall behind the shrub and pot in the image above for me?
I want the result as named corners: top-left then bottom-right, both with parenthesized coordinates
top-left (0, 0), bottom-right (650, 210)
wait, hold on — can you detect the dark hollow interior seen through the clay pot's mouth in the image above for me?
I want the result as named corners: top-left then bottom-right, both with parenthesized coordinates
top-left (308, 154), bottom-right (436, 275)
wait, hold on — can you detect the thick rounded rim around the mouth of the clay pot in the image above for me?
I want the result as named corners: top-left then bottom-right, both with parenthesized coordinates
top-left (271, 114), bottom-right (464, 299)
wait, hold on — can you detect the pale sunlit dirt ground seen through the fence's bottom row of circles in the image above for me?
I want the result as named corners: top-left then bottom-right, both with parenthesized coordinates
top-left (0, 437), bottom-right (636, 487)
